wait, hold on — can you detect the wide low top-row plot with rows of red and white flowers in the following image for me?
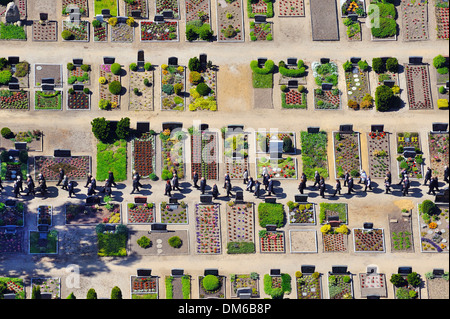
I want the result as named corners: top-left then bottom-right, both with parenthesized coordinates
top-left (140, 20), bottom-right (179, 42)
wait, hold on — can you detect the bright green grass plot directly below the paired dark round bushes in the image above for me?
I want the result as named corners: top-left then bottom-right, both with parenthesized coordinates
top-left (96, 140), bottom-right (127, 183)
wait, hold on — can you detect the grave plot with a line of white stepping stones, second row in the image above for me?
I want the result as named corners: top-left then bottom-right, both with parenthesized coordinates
top-left (345, 66), bottom-right (370, 109)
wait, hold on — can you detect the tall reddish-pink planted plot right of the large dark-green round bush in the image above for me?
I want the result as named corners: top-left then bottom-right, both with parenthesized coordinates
top-left (405, 64), bottom-right (433, 110)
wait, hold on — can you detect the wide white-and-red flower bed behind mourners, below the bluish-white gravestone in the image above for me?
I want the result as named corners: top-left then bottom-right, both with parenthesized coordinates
top-left (256, 157), bottom-right (297, 179)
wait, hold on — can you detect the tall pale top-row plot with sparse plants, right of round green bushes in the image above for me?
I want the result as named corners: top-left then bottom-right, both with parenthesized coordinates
top-left (217, 0), bottom-right (245, 42)
